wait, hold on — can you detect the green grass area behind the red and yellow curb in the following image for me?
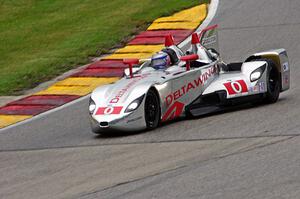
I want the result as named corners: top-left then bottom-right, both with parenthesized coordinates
top-left (0, 0), bottom-right (204, 96)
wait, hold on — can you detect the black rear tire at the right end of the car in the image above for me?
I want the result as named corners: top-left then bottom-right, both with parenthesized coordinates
top-left (255, 59), bottom-right (280, 104)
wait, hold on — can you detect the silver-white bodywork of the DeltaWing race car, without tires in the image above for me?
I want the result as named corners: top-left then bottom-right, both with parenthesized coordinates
top-left (90, 25), bottom-right (290, 133)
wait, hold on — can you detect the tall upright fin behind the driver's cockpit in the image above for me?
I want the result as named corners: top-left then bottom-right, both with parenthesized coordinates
top-left (199, 25), bottom-right (219, 52)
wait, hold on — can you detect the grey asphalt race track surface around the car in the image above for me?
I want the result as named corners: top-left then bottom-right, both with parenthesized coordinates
top-left (0, 0), bottom-right (300, 199)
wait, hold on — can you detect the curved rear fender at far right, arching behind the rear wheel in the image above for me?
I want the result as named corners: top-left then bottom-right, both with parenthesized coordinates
top-left (245, 48), bottom-right (290, 92)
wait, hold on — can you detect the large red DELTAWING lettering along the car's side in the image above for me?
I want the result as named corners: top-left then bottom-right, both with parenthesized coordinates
top-left (165, 66), bottom-right (217, 107)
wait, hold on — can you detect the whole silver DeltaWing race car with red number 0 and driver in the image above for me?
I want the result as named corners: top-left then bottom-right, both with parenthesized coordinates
top-left (89, 25), bottom-right (290, 134)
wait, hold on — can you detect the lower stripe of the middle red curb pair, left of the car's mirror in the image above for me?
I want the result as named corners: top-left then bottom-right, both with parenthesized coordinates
top-left (72, 68), bottom-right (124, 77)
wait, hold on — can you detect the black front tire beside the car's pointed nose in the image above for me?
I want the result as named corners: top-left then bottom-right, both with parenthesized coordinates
top-left (145, 89), bottom-right (160, 130)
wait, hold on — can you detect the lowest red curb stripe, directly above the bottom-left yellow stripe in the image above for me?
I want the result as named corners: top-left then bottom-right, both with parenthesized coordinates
top-left (0, 105), bottom-right (56, 115)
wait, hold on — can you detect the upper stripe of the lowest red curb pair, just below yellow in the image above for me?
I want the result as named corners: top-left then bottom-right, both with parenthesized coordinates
top-left (7, 95), bottom-right (80, 106)
